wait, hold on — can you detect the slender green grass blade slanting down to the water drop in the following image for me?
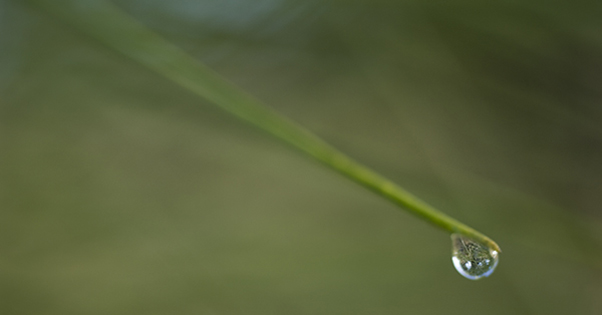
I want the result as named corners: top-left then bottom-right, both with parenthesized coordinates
top-left (30, 0), bottom-right (500, 251)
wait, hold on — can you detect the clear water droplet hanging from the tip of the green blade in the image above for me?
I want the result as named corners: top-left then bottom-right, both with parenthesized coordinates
top-left (452, 234), bottom-right (499, 280)
